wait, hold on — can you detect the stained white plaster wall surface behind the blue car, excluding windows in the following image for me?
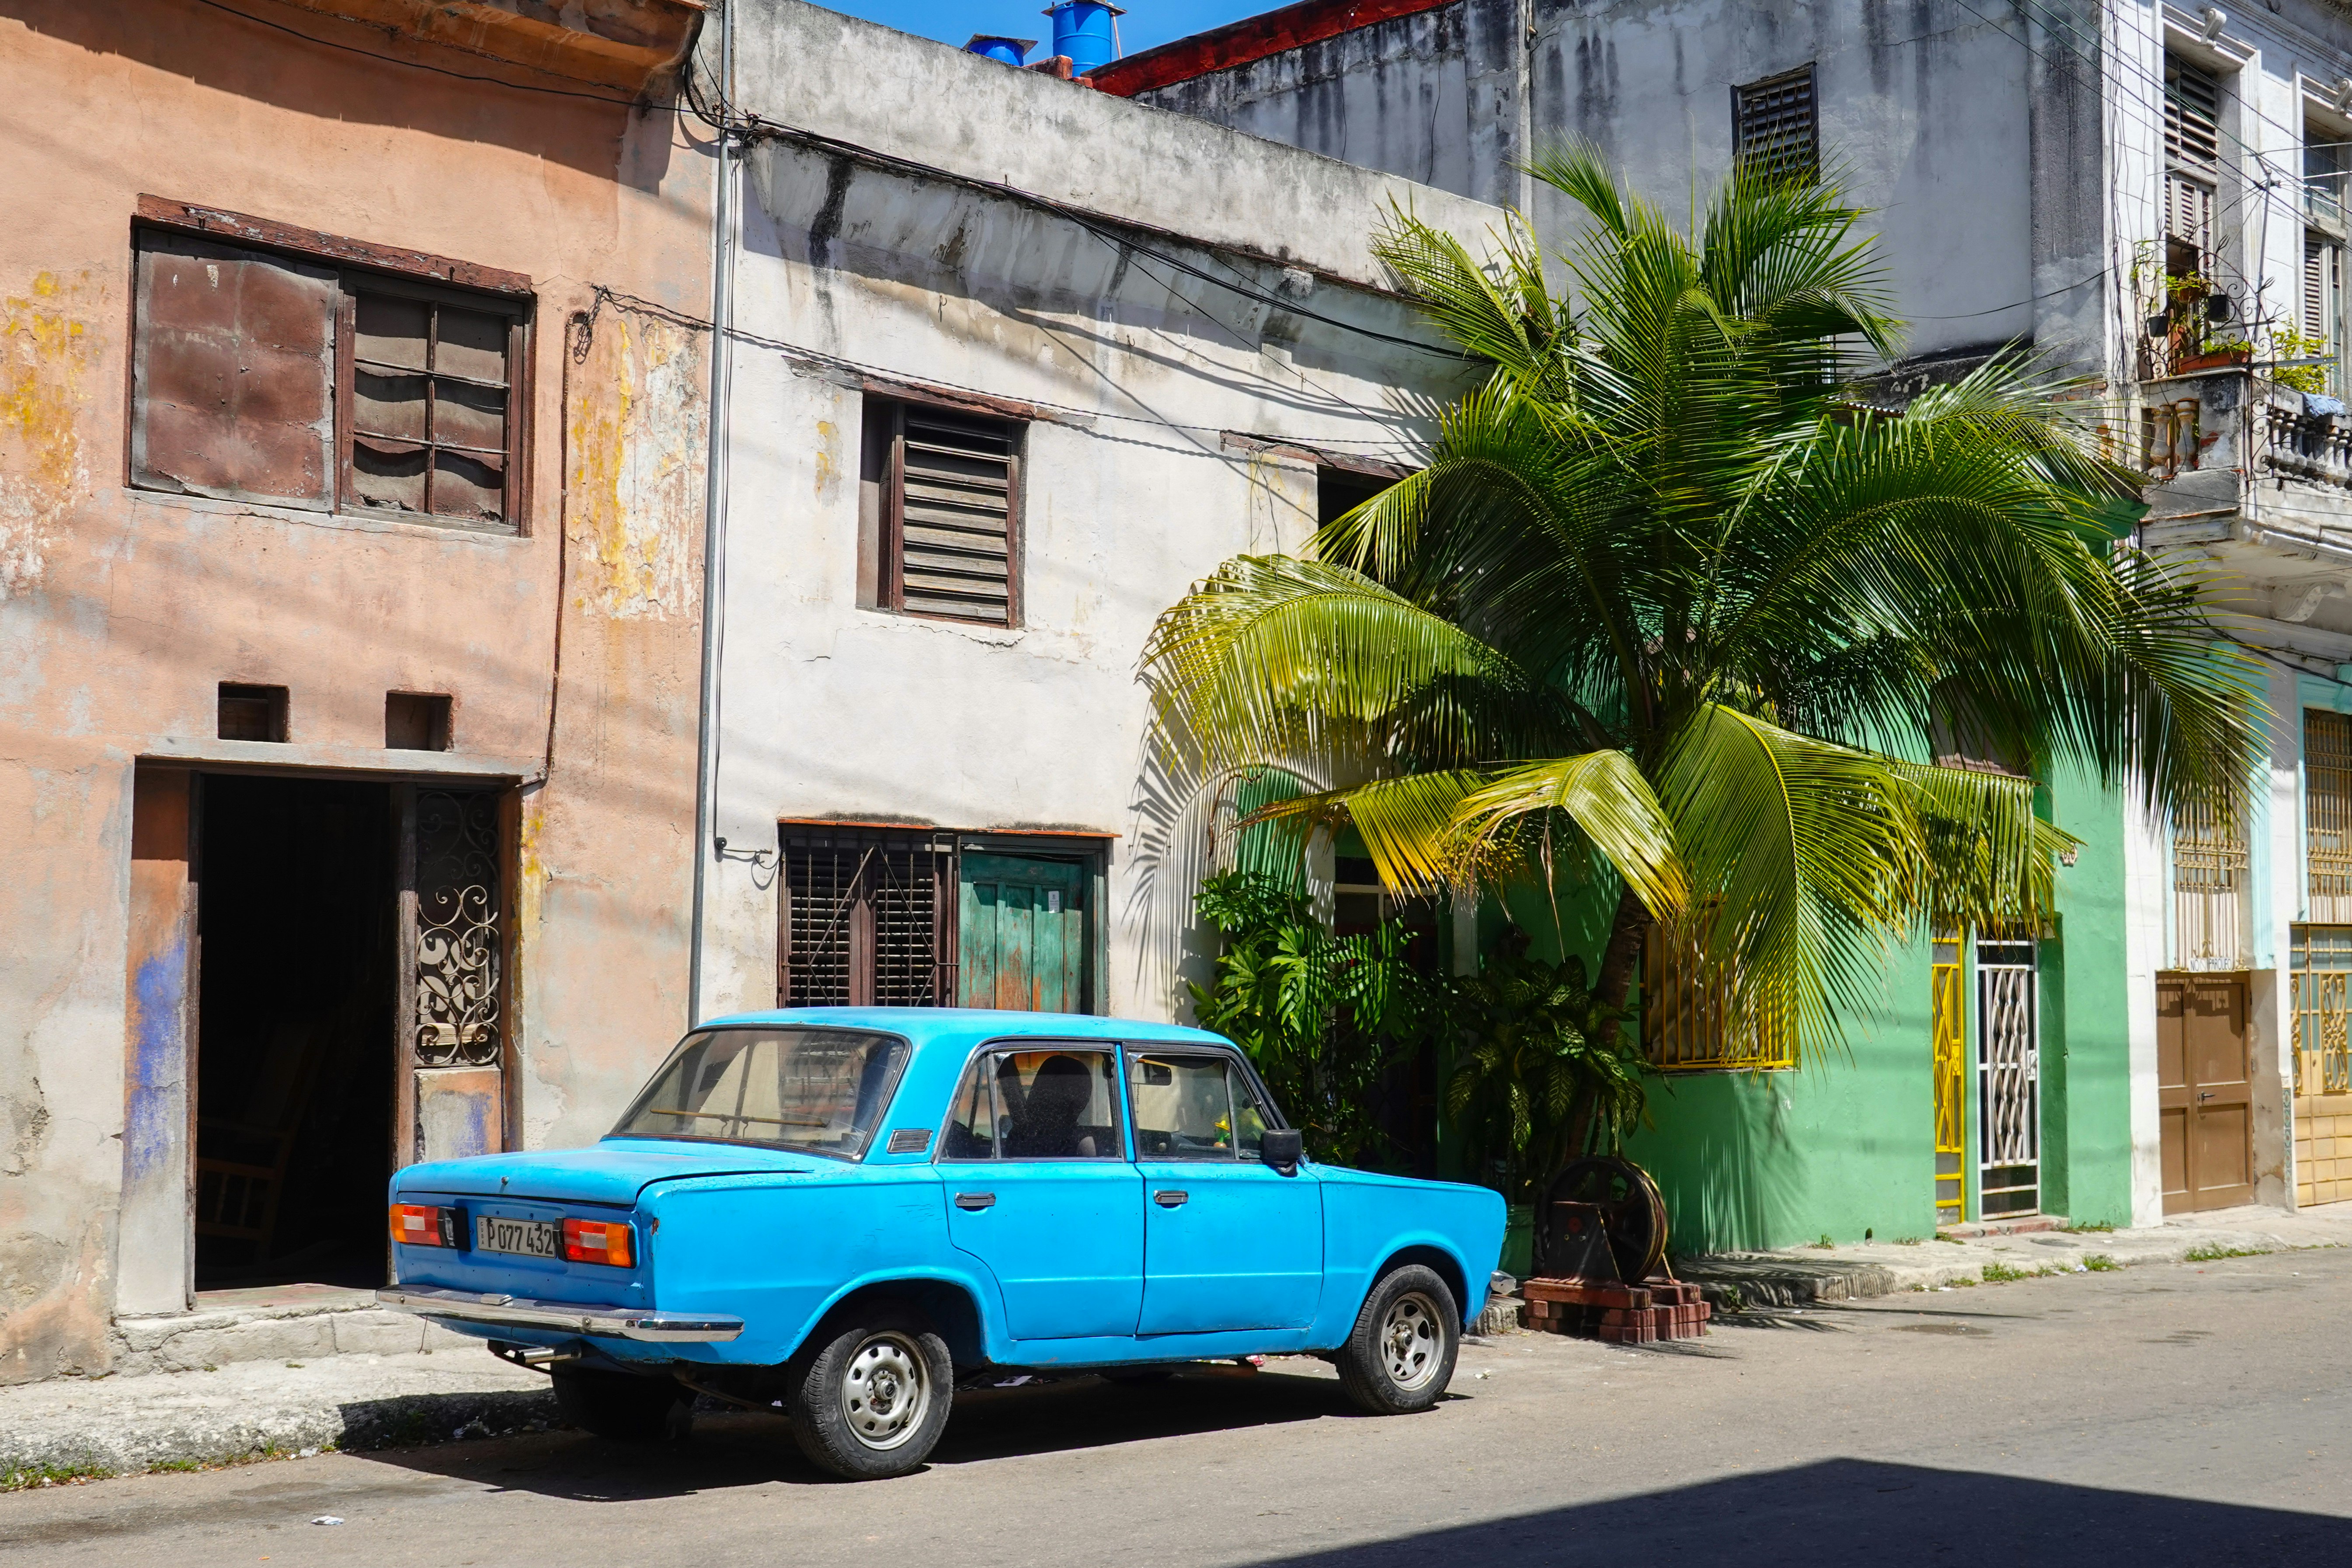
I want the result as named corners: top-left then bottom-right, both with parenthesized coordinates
top-left (706, 5), bottom-right (1496, 1018)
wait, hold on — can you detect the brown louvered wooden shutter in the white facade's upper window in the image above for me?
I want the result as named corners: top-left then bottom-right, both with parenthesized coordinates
top-left (889, 402), bottom-right (1021, 625)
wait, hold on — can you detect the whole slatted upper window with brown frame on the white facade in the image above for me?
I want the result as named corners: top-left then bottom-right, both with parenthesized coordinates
top-left (859, 397), bottom-right (1023, 625)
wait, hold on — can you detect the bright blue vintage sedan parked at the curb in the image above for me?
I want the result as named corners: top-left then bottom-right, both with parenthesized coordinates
top-left (379, 1008), bottom-right (1503, 1479)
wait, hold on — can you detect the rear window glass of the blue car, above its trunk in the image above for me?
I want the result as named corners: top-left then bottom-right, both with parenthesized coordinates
top-left (609, 1029), bottom-right (905, 1159)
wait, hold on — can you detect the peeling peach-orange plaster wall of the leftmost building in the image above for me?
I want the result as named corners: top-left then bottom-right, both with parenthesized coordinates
top-left (0, 0), bottom-right (708, 1380)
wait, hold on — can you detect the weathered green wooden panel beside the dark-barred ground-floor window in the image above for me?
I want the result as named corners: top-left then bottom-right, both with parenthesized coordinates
top-left (957, 853), bottom-right (1087, 1013)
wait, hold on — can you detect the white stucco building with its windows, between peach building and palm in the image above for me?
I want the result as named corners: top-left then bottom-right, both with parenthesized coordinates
top-left (699, 0), bottom-right (1500, 1043)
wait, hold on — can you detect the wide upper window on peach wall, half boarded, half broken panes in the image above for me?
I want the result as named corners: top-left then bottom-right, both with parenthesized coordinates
top-left (132, 228), bottom-right (527, 531)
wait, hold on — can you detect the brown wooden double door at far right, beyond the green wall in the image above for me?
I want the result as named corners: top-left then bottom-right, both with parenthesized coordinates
top-left (2157, 973), bottom-right (2253, 1213)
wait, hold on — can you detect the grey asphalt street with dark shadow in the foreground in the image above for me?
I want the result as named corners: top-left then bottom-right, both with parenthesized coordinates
top-left (0, 1248), bottom-right (2352, 1568)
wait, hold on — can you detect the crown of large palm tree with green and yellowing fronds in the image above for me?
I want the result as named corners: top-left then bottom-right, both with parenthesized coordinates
top-left (1145, 150), bottom-right (2263, 1041)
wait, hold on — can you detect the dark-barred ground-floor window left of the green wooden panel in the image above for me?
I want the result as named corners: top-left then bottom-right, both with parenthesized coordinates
top-left (776, 827), bottom-right (955, 1006)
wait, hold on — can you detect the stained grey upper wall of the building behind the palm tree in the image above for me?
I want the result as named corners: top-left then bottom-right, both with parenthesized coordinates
top-left (1143, 0), bottom-right (2051, 366)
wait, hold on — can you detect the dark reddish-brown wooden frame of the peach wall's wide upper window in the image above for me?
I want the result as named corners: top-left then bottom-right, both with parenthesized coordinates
top-left (122, 195), bottom-right (536, 539)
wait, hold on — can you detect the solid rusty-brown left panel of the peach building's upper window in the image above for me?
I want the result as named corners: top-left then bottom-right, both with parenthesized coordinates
top-left (132, 230), bottom-right (339, 510)
